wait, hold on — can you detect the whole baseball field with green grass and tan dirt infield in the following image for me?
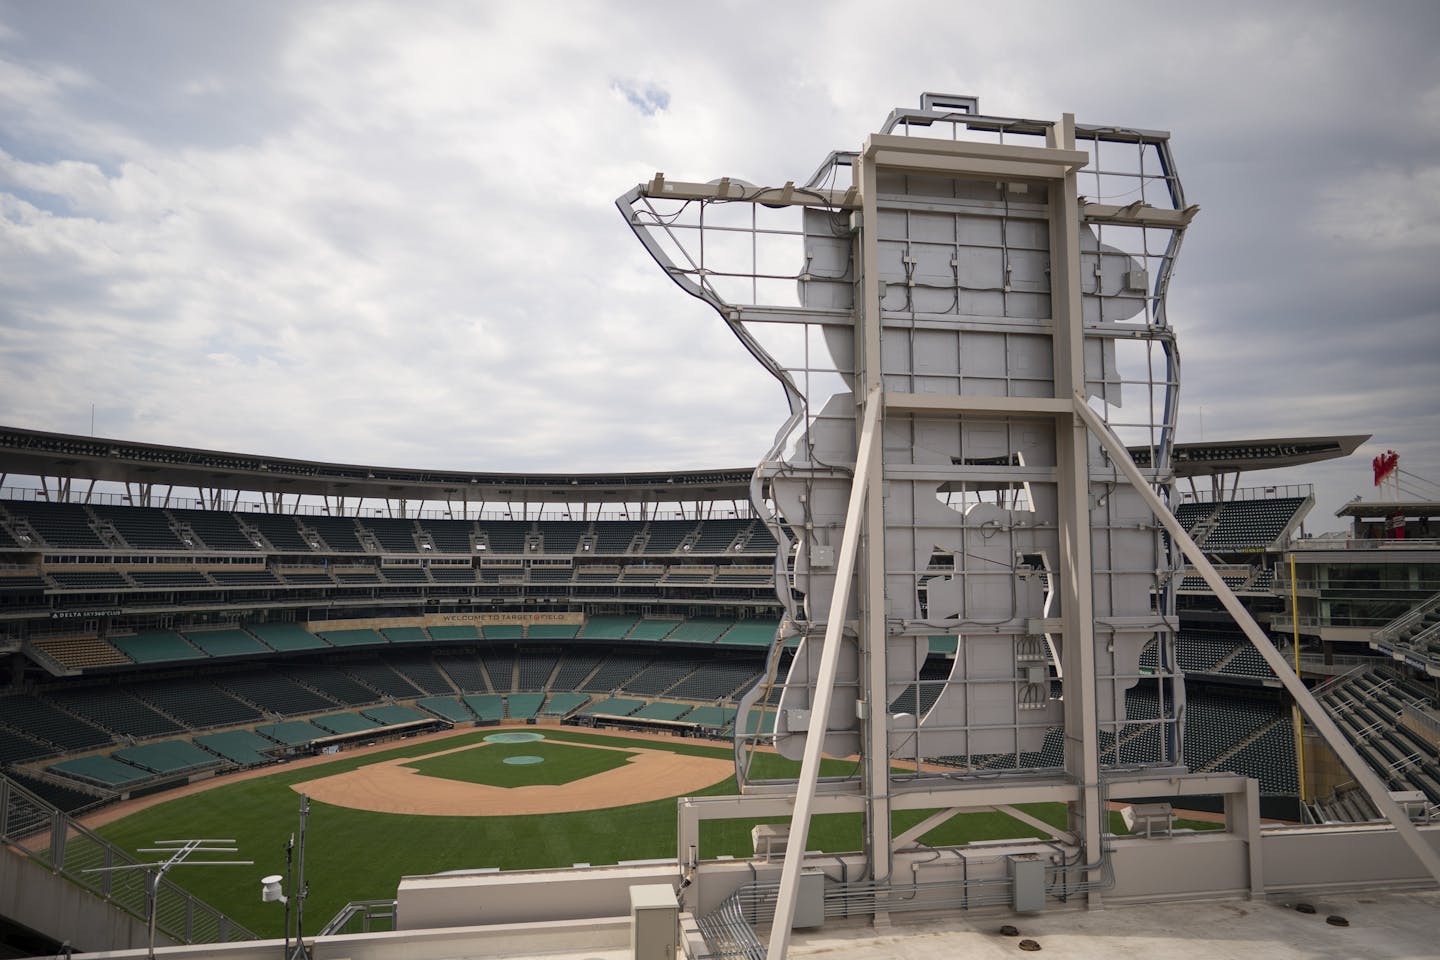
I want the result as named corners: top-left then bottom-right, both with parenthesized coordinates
top-left (95, 727), bottom-right (1186, 937)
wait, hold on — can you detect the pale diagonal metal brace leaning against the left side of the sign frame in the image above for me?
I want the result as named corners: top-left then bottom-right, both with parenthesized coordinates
top-left (766, 391), bottom-right (881, 960)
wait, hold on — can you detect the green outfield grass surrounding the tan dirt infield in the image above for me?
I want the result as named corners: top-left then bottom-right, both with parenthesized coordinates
top-left (99, 728), bottom-right (1215, 937)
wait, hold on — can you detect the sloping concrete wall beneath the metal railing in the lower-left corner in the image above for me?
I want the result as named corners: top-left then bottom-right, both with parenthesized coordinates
top-left (0, 848), bottom-right (162, 951)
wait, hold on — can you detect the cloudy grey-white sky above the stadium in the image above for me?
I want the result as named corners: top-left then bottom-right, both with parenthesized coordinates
top-left (0, 0), bottom-right (1440, 530)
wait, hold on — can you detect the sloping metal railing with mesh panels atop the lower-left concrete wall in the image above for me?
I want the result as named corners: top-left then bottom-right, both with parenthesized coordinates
top-left (0, 776), bottom-right (256, 943)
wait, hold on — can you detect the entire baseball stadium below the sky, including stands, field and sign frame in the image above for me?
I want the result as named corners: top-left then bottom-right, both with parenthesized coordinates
top-left (0, 94), bottom-right (1440, 960)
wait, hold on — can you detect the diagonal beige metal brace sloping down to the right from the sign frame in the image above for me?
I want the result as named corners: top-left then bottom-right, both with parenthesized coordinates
top-left (1074, 396), bottom-right (1440, 884)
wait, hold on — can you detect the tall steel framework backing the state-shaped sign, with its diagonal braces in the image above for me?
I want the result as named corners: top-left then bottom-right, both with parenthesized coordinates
top-left (618, 95), bottom-right (1440, 957)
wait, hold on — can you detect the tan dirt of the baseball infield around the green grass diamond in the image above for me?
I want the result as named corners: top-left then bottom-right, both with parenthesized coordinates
top-left (291, 740), bottom-right (734, 816)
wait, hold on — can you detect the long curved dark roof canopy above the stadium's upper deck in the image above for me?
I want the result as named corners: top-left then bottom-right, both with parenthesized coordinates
top-left (0, 426), bottom-right (1369, 502)
